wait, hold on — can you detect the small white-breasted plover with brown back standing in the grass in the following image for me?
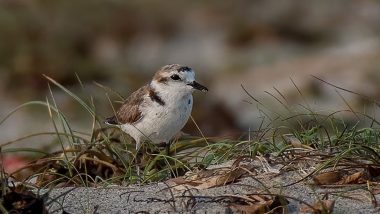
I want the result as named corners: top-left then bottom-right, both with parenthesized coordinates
top-left (105, 64), bottom-right (208, 152)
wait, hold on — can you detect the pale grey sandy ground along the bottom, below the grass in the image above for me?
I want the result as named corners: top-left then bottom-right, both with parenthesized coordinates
top-left (49, 166), bottom-right (380, 213)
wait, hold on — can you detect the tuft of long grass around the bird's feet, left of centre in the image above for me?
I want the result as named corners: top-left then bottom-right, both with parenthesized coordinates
top-left (0, 76), bottom-right (234, 188)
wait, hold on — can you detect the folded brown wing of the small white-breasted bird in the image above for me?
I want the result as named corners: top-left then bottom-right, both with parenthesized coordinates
top-left (106, 86), bottom-right (148, 125)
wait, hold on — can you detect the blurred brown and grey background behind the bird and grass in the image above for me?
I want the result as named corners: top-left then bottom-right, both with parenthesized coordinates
top-left (0, 0), bottom-right (380, 155)
